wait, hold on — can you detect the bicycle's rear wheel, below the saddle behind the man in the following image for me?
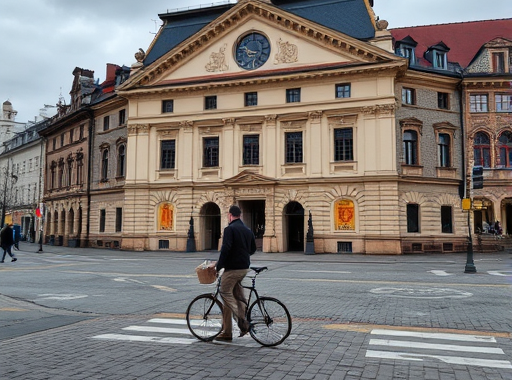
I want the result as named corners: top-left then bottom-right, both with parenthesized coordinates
top-left (247, 297), bottom-right (292, 347)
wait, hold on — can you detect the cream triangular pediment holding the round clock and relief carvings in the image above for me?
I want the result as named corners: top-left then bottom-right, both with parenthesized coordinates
top-left (119, 0), bottom-right (405, 91)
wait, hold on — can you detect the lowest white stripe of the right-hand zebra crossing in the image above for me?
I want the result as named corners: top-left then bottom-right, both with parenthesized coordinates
top-left (366, 350), bottom-right (512, 369)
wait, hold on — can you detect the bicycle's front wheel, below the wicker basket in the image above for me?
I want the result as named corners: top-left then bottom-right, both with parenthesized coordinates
top-left (187, 294), bottom-right (222, 342)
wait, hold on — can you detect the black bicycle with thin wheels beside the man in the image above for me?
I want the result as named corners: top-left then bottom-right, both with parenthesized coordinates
top-left (187, 267), bottom-right (292, 347)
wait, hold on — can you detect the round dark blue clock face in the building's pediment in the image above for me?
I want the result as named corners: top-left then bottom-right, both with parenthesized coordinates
top-left (235, 32), bottom-right (270, 70)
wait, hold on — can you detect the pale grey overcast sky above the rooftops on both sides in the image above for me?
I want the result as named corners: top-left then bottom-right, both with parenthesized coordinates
top-left (0, 0), bottom-right (512, 123)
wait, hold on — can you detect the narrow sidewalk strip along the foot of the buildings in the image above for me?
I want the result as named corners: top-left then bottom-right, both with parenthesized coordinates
top-left (14, 242), bottom-right (512, 264)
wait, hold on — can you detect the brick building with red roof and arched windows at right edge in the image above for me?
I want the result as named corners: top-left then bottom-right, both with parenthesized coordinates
top-left (391, 19), bottom-right (512, 238)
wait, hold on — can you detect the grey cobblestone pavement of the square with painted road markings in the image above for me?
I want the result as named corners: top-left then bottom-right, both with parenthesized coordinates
top-left (0, 243), bottom-right (512, 380)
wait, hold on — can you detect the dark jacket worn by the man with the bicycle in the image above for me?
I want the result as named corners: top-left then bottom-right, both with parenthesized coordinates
top-left (217, 219), bottom-right (256, 271)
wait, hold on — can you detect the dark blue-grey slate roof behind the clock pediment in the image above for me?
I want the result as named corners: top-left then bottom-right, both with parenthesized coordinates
top-left (144, 0), bottom-right (375, 66)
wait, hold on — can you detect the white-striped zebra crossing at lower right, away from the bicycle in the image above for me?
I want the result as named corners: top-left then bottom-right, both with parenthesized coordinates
top-left (366, 329), bottom-right (512, 369)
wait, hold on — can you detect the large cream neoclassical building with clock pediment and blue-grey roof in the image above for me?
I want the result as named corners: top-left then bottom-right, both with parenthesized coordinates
top-left (118, 0), bottom-right (467, 254)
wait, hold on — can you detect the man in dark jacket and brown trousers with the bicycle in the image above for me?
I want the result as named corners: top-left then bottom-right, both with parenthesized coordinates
top-left (216, 206), bottom-right (256, 340)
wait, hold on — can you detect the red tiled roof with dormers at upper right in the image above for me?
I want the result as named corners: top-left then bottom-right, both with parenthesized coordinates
top-left (390, 18), bottom-right (512, 68)
